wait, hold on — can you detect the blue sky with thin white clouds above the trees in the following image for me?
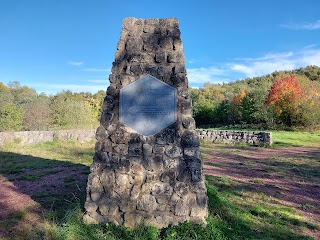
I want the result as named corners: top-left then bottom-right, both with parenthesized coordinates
top-left (0, 0), bottom-right (320, 94)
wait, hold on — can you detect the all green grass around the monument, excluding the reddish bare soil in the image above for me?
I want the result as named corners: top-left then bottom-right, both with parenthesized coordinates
top-left (0, 138), bottom-right (320, 240)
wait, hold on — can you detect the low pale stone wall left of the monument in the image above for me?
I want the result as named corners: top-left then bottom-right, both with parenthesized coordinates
top-left (0, 130), bottom-right (96, 146)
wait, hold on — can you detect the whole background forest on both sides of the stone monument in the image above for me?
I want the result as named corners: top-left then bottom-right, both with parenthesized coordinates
top-left (0, 66), bottom-right (320, 131)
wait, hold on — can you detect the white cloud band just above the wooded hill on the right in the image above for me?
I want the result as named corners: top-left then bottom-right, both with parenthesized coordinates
top-left (187, 45), bottom-right (320, 87)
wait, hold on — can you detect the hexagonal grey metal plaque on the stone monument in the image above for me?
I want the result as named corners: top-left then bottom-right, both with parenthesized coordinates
top-left (120, 75), bottom-right (177, 136)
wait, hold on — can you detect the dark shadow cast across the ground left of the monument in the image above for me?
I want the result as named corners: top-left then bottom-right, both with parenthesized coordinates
top-left (0, 152), bottom-right (89, 220)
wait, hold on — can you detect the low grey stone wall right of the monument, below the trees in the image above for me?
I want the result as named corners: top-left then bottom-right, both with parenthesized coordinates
top-left (197, 129), bottom-right (272, 146)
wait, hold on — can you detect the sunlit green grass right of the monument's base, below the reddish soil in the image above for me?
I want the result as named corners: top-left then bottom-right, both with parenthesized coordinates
top-left (207, 176), bottom-right (318, 239)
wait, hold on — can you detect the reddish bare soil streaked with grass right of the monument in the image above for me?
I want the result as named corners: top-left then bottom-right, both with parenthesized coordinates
top-left (204, 146), bottom-right (320, 239)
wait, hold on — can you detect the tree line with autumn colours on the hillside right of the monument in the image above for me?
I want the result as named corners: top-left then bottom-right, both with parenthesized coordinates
top-left (190, 66), bottom-right (320, 129)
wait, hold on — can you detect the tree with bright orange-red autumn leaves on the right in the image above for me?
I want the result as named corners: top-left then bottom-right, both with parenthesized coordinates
top-left (265, 75), bottom-right (303, 126)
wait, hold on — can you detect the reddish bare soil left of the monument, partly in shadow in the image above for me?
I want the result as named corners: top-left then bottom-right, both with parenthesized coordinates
top-left (0, 165), bottom-right (87, 239)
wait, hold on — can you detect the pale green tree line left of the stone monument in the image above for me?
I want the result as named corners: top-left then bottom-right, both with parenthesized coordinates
top-left (0, 82), bottom-right (105, 131)
